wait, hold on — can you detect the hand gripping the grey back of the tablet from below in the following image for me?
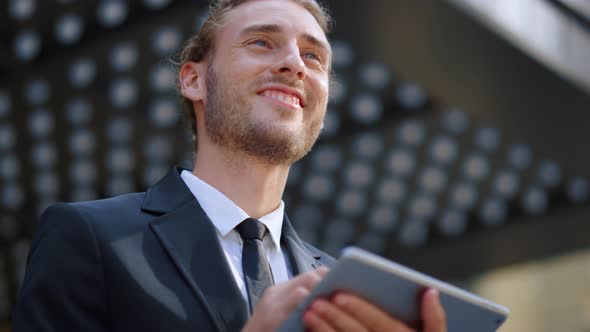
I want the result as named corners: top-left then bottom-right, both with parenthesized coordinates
top-left (303, 289), bottom-right (447, 332)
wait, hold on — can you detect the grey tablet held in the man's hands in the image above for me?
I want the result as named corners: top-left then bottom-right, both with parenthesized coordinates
top-left (279, 247), bottom-right (509, 332)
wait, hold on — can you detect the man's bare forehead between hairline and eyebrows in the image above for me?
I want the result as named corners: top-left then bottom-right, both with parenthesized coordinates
top-left (220, 0), bottom-right (328, 45)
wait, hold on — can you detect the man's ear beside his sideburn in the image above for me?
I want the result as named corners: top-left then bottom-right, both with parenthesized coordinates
top-left (178, 61), bottom-right (207, 103)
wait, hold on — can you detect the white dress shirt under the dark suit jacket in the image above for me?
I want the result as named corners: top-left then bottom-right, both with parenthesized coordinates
top-left (180, 170), bottom-right (293, 303)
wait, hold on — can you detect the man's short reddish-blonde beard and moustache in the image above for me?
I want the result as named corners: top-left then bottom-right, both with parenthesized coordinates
top-left (205, 64), bottom-right (326, 165)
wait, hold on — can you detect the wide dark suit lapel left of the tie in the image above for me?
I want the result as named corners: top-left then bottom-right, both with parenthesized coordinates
top-left (143, 169), bottom-right (248, 331)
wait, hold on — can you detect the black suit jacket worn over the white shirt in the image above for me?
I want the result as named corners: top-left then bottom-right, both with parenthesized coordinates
top-left (12, 168), bottom-right (333, 332)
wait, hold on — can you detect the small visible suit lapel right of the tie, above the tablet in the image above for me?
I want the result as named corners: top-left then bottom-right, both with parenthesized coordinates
top-left (281, 214), bottom-right (323, 275)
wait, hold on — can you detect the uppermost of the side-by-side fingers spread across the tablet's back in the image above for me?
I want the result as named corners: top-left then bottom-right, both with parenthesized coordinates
top-left (333, 293), bottom-right (413, 332)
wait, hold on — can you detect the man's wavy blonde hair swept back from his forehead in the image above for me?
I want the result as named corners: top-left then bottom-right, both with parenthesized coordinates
top-left (178, 0), bottom-right (333, 145)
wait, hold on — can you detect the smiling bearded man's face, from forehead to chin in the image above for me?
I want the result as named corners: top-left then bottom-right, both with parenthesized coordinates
top-left (205, 0), bottom-right (331, 165)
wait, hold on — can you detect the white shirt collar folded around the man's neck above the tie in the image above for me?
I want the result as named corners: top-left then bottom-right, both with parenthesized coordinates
top-left (180, 170), bottom-right (285, 248)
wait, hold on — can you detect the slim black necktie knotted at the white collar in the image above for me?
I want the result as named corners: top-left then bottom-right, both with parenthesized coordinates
top-left (236, 218), bottom-right (273, 312)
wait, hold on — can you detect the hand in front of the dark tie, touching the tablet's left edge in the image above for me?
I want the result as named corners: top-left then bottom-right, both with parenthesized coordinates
top-left (242, 266), bottom-right (328, 332)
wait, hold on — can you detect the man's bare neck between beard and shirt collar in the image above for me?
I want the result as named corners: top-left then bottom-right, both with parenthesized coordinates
top-left (193, 144), bottom-right (289, 218)
